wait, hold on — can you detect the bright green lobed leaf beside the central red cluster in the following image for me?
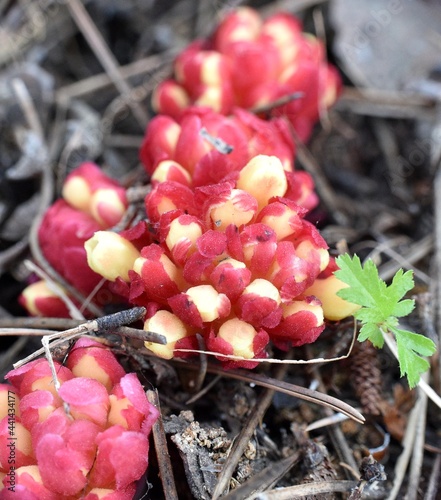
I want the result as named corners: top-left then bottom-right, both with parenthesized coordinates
top-left (334, 254), bottom-right (436, 387)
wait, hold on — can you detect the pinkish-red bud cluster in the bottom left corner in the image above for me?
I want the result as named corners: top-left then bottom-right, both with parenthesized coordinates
top-left (0, 339), bottom-right (158, 500)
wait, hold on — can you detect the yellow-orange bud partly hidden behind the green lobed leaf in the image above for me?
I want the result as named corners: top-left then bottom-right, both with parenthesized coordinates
top-left (305, 275), bottom-right (360, 321)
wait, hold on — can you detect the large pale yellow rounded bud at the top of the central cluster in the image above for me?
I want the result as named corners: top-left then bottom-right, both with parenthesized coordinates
top-left (237, 155), bottom-right (288, 210)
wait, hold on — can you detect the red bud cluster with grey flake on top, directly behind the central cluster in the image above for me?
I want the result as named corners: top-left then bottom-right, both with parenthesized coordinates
top-left (140, 107), bottom-right (318, 211)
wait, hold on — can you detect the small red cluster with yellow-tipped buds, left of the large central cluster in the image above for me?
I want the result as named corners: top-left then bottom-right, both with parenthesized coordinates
top-left (19, 162), bottom-right (127, 317)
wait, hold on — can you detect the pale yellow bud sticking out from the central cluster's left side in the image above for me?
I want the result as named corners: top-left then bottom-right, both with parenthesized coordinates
top-left (84, 231), bottom-right (140, 281)
